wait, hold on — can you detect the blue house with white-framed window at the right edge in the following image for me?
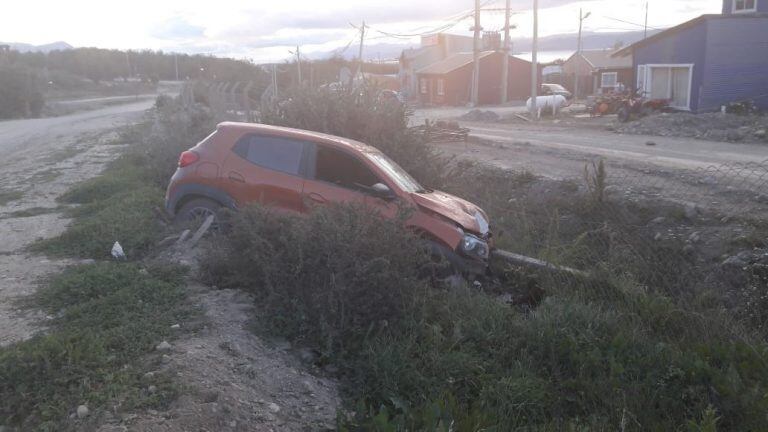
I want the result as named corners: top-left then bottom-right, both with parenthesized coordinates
top-left (614, 0), bottom-right (768, 112)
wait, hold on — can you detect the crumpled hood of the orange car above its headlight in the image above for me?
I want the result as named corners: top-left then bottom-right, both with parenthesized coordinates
top-left (411, 191), bottom-right (488, 235)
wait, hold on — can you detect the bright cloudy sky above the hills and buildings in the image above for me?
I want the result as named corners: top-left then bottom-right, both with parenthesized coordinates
top-left (0, 0), bottom-right (722, 63)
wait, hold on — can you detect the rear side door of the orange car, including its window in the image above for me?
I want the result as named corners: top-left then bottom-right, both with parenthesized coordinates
top-left (223, 134), bottom-right (308, 212)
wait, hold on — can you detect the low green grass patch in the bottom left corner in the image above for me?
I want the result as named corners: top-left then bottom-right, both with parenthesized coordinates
top-left (0, 262), bottom-right (194, 431)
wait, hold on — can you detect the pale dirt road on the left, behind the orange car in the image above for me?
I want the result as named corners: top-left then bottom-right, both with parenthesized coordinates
top-left (0, 101), bottom-right (152, 345)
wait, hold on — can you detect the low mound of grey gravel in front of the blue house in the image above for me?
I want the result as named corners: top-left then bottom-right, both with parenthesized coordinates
top-left (614, 113), bottom-right (768, 143)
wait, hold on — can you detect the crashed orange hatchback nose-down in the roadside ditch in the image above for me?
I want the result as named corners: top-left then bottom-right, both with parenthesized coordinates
top-left (165, 122), bottom-right (493, 274)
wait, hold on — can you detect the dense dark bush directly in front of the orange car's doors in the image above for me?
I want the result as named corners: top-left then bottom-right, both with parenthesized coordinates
top-left (201, 205), bottom-right (427, 356)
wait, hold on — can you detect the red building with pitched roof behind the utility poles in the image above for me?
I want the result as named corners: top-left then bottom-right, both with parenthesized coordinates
top-left (416, 51), bottom-right (541, 105)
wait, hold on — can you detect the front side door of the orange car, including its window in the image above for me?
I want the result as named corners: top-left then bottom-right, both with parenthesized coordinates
top-left (303, 144), bottom-right (390, 211)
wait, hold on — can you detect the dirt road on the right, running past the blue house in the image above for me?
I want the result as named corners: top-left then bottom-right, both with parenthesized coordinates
top-left (438, 122), bottom-right (768, 221)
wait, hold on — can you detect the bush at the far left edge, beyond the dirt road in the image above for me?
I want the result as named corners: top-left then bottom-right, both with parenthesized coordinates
top-left (0, 65), bottom-right (45, 118)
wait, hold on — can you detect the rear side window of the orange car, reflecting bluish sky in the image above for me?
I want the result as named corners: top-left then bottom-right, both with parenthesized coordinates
top-left (232, 135), bottom-right (306, 175)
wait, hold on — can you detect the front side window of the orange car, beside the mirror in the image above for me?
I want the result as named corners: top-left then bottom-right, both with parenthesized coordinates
top-left (315, 145), bottom-right (381, 192)
